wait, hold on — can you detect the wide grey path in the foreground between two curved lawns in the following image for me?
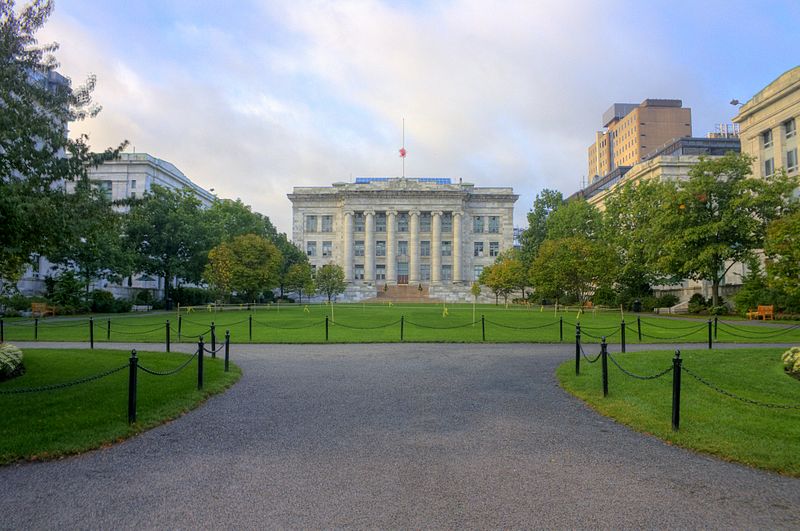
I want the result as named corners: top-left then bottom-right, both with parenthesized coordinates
top-left (0, 344), bottom-right (800, 529)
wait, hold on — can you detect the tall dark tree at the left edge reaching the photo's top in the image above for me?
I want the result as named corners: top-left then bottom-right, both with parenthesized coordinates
top-left (0, 0), bottom-right (125, 285)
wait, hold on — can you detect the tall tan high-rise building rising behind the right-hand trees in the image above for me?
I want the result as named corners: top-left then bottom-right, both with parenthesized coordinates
top-left (586, 99), bottom-right (692, 184)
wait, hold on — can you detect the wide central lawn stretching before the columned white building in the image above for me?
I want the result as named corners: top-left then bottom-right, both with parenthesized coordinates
top-left (4, 304), bottom-right (800, 344)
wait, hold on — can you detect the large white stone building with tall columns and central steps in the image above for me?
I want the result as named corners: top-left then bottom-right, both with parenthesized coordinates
top-left (289, 177), bottom-right (519, 300)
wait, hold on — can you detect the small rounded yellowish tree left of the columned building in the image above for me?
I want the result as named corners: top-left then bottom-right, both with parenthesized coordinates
top-left (203, 234), bottom-right (283, 301)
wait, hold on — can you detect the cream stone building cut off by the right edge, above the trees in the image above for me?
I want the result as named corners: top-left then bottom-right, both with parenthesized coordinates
top-left (733, 66), bottom-right (800, 177)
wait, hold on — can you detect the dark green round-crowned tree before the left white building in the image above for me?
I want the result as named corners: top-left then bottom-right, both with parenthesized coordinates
top-left (125, 186), bottom-right (210, 301)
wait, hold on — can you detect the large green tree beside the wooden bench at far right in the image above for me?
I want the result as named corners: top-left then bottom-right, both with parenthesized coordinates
top-left (652, 153), bottom-right (797, 306)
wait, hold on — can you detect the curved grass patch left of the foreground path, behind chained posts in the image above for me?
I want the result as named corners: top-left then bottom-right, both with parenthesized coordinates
top-left (0, 349), bottom-right (241, 464)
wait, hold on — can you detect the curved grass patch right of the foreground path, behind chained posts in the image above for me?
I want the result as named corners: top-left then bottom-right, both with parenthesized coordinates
top-left (556, 348), bottom-right (800, 476)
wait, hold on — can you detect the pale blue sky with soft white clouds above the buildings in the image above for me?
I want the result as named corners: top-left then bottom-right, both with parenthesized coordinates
top-left (38, 0), bottom-right (800, 233)
